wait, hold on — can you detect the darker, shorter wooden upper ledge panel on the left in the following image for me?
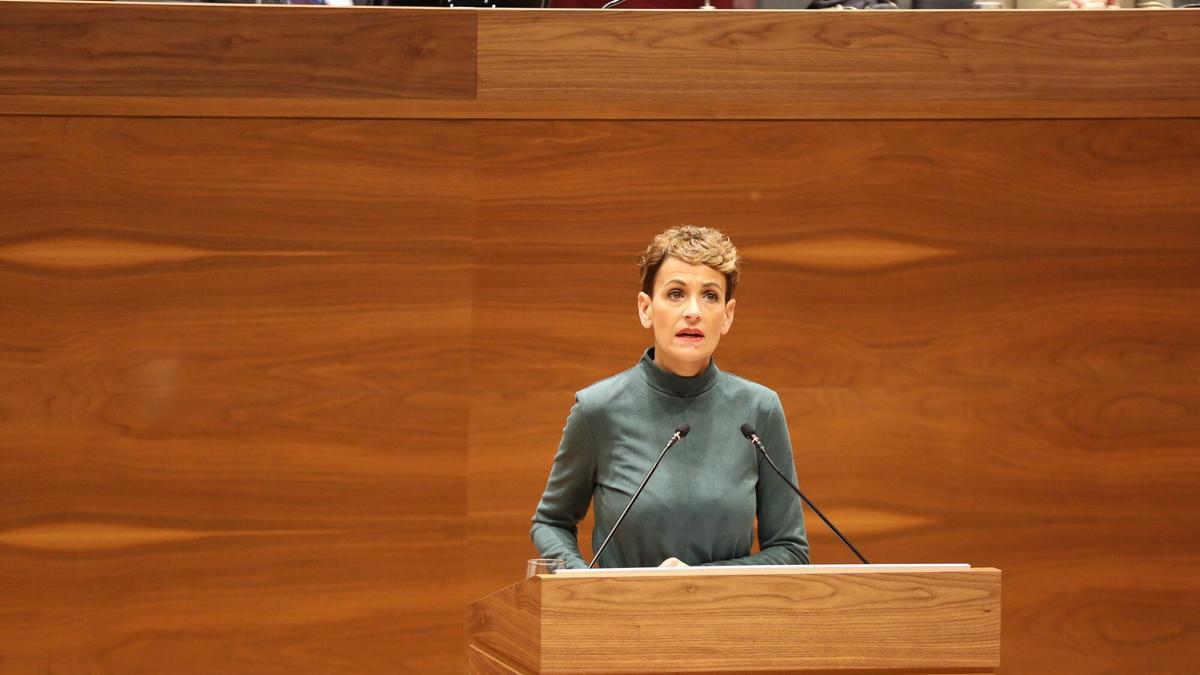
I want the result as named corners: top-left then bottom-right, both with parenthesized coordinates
top-left (0, 2), bottom-right (475, 99)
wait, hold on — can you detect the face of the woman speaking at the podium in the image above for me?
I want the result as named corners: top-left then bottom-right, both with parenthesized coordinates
top-left (637, 256), bottom-right (734, 377)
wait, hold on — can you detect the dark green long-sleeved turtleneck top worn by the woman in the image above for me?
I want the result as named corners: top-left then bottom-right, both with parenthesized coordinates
top-left (530, 348), bottom-right (809, 568)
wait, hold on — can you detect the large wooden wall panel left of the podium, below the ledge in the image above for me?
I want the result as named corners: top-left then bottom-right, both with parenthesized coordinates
top-left (0, 118), bottom-right (470, 673)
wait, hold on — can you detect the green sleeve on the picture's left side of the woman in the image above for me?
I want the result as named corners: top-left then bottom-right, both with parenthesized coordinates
top-left (529, 396), bottom-right (596, 568)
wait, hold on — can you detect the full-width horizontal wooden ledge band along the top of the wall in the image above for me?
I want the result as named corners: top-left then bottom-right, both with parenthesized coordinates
top-left (0, 1), bottom-right (1200, 120)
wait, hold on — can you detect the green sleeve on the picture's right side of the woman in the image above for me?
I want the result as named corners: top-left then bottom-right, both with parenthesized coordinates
top-left (709, 396), bottom-right (809, 565)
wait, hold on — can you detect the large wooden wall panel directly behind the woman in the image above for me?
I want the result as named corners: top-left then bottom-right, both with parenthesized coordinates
top-left (469, 120), bottom-right (1200, 673)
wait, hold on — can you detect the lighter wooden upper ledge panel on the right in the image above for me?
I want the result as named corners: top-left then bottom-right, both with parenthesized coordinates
top-left (479, 12), bottom-right (1200, 109)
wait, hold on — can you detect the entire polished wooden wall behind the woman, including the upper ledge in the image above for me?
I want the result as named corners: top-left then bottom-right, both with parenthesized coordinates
top-left (0, 2), bottom-right (1200, 674)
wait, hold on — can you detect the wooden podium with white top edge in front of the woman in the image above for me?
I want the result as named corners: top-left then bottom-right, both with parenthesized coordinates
top-left (468, 565), bottom-right (1001, 675)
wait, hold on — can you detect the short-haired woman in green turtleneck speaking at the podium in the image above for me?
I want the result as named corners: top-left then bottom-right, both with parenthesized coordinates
top-left (530, 226), bottom-right (809, 568)
